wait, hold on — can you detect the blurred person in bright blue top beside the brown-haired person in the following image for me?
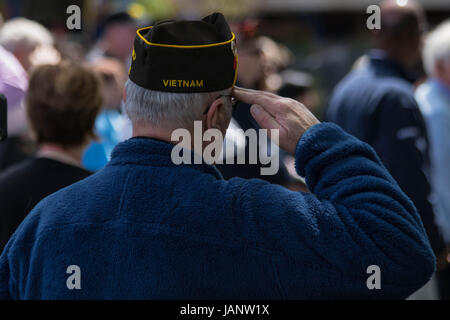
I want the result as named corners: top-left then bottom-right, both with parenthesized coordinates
top-left (83, 58), bottom-right (131, 171)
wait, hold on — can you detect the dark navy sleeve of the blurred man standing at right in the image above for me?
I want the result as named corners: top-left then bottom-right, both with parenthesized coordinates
top-left (372, 90), bottom-right (445, 255)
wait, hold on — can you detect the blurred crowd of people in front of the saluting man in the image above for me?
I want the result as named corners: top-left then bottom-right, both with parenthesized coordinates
top-left (0, 1), bottom-right (450, 299)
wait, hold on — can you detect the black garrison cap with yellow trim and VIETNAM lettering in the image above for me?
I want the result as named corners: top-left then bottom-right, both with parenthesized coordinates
top-left (129, 13), bottom-right (237, 93)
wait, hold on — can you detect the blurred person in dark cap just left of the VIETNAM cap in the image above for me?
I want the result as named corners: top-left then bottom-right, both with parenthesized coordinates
top-left (87, 12), bottom-right (138, 72)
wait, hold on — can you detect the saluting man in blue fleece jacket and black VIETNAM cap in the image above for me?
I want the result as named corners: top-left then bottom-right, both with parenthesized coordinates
top-left (0, 13), bottom-right (435, 299)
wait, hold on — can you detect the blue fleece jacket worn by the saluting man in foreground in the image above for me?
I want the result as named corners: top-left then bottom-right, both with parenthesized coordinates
top-left (0, 123), bottom-right (435, 299)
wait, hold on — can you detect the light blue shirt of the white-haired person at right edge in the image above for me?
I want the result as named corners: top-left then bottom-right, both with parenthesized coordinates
top-left (416, 79), bottom-right (450, 243)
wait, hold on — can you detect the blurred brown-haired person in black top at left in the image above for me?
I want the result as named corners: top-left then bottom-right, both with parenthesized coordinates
top-left (0, 62), bottom-right (102, 249)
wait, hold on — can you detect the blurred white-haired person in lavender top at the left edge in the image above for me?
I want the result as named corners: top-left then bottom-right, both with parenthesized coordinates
top-left (0, 18), bottom-right (60, 171)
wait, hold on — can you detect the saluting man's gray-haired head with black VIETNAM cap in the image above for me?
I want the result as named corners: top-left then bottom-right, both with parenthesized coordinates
top-left (125, 14), bottom-right (237, 130)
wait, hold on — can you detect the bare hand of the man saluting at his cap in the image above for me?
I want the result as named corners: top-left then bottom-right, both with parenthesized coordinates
top-left (232, 87), bottom-right (319, 155)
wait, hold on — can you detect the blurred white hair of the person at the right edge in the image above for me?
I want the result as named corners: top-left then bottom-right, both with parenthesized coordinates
top-left (423, 19), bottom-right (450, 76)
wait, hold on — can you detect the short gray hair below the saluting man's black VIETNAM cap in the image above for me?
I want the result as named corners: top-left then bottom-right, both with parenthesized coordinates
top-left (124, 80), bottom-right (231, 129)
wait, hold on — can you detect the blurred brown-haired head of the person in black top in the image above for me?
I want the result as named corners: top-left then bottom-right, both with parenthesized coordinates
top-left (25, 62), bottom-right (102, 148)
